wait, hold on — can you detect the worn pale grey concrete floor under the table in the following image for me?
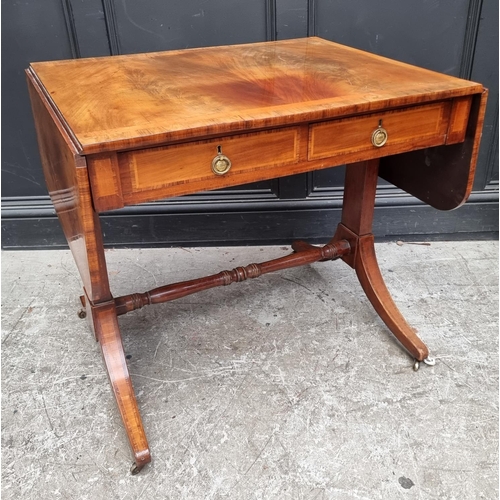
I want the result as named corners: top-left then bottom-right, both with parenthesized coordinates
top-left (2, 241), bottom-right (498, 500)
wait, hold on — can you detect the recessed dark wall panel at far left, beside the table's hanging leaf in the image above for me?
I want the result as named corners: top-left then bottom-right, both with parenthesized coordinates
top-left (2, 0), bottom-right (72, 197)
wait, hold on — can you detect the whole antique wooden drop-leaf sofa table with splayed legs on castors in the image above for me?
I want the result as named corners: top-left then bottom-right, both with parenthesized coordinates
top-left (26, 37), bottom-right (487, 473)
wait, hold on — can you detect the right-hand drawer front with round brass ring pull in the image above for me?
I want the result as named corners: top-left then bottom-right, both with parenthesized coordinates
top-left (308, 102), bottom-right (451, 160)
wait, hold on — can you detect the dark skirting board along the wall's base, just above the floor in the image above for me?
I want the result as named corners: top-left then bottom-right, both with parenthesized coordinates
top-left (2, 203), bottom-right (498, 249)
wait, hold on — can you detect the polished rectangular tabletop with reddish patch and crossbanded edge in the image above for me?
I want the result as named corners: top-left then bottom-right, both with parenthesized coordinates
top-left (29, 37), bottom-right (482, 153)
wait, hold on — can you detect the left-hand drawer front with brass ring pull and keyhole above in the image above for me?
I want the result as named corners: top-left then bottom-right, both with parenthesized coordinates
top-left (118, 127), bottom-right (299, 204)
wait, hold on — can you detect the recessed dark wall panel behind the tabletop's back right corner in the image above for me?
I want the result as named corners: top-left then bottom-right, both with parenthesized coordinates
top-left (316, 0), bottom-right (469, 76)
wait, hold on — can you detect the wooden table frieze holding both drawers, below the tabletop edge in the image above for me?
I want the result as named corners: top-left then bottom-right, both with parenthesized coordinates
top-left (87, 96), bottom-right (471, 212)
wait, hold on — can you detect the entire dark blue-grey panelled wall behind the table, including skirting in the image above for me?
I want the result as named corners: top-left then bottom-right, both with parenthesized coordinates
top-left (2, 0), bottom-right (498, 248)
